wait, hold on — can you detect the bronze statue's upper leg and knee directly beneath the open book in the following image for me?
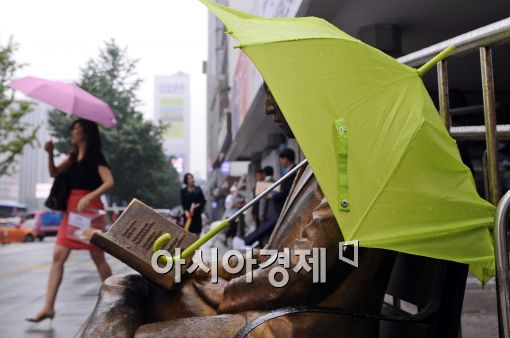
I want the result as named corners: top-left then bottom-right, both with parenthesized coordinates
top-left (77, 275), bottom-right (223, 338)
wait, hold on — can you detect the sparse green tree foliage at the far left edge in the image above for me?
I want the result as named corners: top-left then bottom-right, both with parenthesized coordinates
top-left (0, 39), bottom-right (38, 176)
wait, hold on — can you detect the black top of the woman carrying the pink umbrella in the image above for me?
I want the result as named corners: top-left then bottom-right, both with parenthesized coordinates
top-left (66, 151), bottom-right (108, 190)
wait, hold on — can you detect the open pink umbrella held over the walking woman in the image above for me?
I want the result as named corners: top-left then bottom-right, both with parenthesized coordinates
top-left (9, 76), bottom-right (117, 127)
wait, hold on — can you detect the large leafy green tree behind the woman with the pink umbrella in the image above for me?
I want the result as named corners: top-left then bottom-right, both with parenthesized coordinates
top-left (50, 40), bottom-right (180, 208)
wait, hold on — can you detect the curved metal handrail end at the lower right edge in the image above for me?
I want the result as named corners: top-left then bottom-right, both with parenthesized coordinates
top-left (494, 190), bottom-right (510, 338)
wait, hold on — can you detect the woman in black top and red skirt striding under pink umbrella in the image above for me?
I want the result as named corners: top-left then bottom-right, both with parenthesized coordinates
top-left (26, 119), bottom-right (113, 322)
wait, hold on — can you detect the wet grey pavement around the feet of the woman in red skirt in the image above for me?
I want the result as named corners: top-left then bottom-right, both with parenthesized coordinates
top-left (0, 238), bottom-right (132, 338)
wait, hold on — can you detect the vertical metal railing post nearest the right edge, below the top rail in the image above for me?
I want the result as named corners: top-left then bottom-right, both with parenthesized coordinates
top-left (480, 47), bottom-right (501, 205)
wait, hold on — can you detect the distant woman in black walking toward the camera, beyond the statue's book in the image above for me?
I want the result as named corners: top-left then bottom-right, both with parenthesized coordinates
top-left (181, 173), bottom-right (205, 235)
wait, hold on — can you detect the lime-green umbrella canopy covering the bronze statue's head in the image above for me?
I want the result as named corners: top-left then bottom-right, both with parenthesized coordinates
top-left (202, 0), bottom-right (495, 281)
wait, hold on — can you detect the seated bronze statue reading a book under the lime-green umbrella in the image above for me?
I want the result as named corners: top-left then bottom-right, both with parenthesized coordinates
top-left (78, 87), bottom-right (394, 337)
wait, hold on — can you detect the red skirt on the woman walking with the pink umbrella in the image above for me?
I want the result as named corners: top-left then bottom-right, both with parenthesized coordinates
top-left (57, 189), bottom-right (104, 251)
